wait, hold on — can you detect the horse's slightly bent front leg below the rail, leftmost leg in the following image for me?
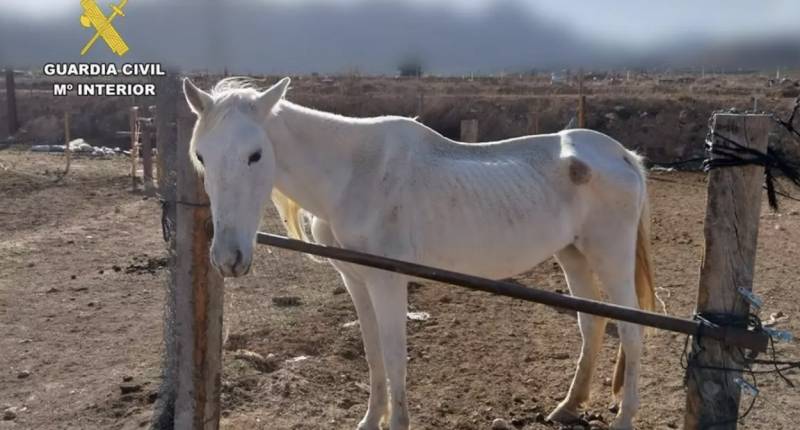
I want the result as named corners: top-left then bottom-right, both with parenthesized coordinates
top-left (342, 274), bottom-right (389, 430)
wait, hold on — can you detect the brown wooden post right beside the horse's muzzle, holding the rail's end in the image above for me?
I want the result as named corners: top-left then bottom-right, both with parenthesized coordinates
top-left (175, 92), bottom-right (224, 430)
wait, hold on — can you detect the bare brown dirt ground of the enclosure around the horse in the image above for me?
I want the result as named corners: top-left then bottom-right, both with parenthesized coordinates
top-left (0, 150), bottom-right (800, 429)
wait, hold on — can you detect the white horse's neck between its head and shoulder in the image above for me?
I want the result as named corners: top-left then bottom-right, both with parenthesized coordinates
top-left (267, 101), bottom-right (369, 219)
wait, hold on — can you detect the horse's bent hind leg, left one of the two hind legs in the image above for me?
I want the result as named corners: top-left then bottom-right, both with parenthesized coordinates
top-left (548, 246), bottom-right (606, 423)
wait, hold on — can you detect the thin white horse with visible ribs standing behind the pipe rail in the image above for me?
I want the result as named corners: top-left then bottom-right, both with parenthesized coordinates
top-left (184, 78), bottom-right (655, 430)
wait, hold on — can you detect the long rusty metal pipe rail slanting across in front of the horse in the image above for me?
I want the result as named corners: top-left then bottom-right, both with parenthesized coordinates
top-left (256, 232), bottom-right (769, 352)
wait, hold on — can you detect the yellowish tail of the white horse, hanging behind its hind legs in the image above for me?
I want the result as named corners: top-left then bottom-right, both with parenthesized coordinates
top-left (612, 160), bottom-right (657, 396)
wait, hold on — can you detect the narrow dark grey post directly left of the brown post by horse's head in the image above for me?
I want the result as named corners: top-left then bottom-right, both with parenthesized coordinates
top-left (151, 71), bottom-right (180, 430)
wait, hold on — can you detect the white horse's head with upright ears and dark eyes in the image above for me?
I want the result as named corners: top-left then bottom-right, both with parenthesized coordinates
top-left (183, 78), bottom-right (289, 276)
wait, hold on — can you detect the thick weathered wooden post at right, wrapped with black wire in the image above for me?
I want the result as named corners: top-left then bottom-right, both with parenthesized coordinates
top-left (684, 114), bottom-right (772, 430)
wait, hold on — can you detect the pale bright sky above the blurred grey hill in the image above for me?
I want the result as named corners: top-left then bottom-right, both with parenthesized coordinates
top-left (0, 0), bottom-right (800, 48)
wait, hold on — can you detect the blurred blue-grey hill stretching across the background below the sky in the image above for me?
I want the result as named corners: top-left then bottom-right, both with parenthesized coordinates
top-left (0, 0), bottom-right (800, 74)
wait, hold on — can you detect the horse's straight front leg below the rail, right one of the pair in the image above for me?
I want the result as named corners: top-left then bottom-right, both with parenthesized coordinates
top-left (367, 273), bottom-right (409, 430)
